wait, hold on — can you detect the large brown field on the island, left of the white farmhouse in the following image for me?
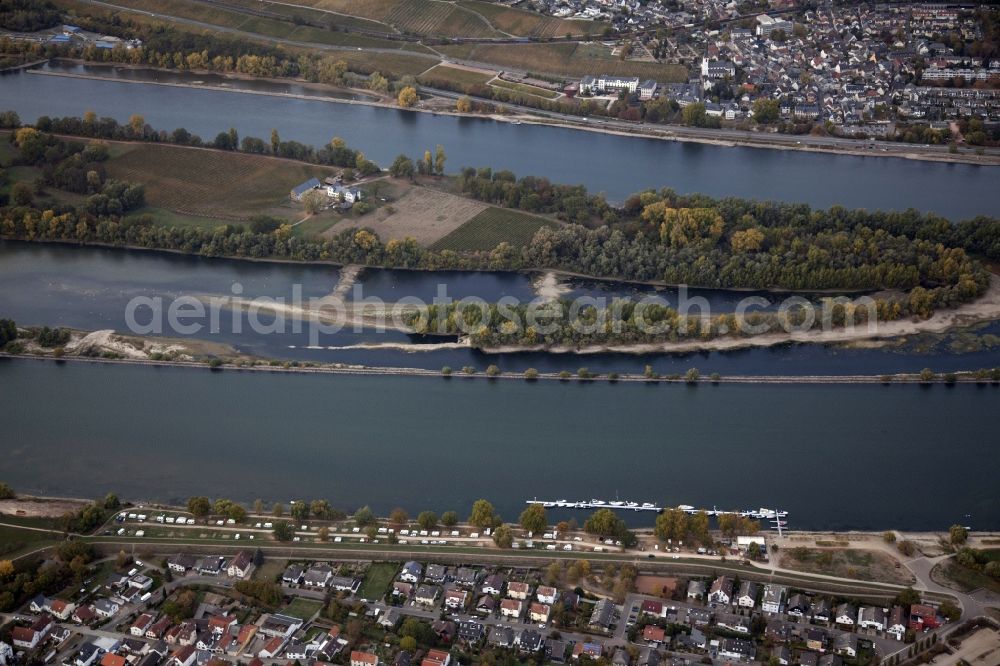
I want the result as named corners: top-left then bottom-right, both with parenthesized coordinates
top-left (107, 144), bottom-right (334, 222)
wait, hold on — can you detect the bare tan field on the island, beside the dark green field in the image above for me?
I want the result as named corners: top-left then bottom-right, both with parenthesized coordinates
top-left (363, 186), bottom-right (487, 246)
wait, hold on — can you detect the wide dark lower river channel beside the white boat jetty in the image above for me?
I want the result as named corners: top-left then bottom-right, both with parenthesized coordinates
top-left (0, 360), bottom-right (1000, 530)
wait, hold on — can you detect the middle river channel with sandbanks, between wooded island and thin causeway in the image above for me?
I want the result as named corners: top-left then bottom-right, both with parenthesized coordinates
top-left (0, 241), bottom-right (1000, 375)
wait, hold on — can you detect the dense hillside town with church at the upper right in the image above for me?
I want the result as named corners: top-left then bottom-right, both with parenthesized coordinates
top-left (557, 0), bottom-right (1000, 140)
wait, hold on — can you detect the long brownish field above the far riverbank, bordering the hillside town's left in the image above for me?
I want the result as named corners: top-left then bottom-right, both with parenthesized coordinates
top-left (438, 42), bottom-right (688, 83)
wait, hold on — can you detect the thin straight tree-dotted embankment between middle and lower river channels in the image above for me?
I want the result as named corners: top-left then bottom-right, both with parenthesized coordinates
top-left (0, 352), bottom-right (1000, 387)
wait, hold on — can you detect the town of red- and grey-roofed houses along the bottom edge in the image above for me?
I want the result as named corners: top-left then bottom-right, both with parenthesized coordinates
top-left (0, 506), bottom-right (957, 666)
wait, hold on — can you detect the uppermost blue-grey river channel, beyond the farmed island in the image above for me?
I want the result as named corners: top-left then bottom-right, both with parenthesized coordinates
top-left (0, 65), bottom-right (1000, 215)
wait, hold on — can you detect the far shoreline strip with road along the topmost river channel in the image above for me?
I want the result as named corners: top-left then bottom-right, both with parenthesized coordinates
top-left (23, 58), bottom-right (1000, 166)
